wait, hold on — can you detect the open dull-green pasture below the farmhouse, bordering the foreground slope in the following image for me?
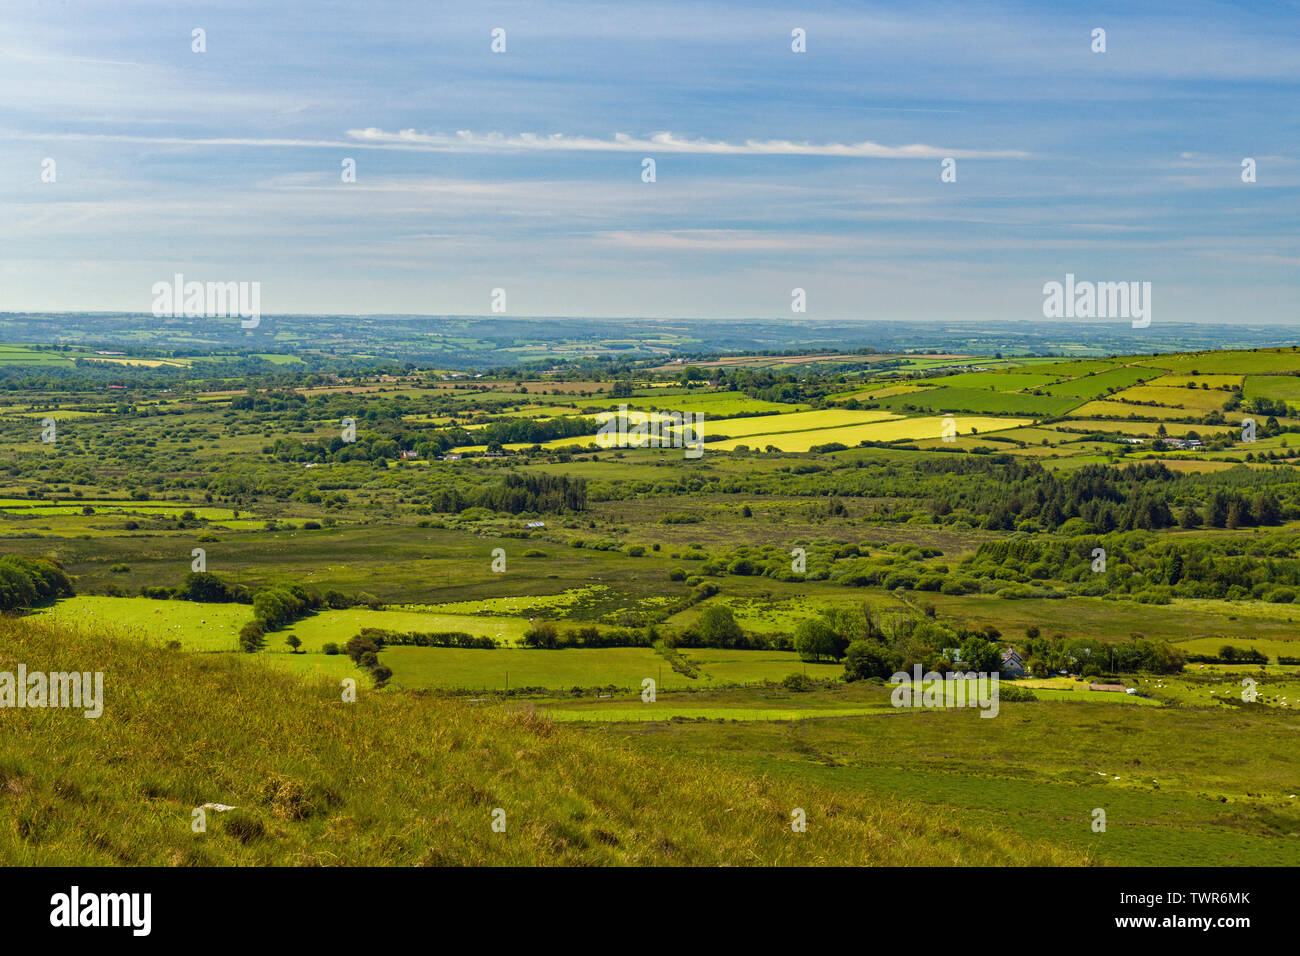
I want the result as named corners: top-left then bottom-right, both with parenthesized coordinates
top-left (616, 701), bottom-right (1300, 866)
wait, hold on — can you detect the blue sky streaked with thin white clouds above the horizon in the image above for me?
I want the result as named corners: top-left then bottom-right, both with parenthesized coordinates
top-left (0, 0), bottom-right (1300, 329)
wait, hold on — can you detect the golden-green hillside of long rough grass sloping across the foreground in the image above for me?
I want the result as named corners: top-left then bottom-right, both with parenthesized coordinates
top-left (0, 619), bottom-right (1091, 866)
